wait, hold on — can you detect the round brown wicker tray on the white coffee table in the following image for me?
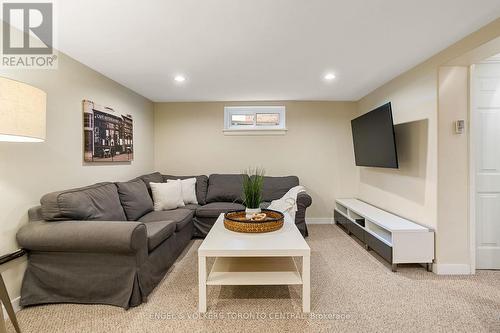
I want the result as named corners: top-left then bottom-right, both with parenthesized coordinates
top-left (224, 209), bottom-right (284, 233)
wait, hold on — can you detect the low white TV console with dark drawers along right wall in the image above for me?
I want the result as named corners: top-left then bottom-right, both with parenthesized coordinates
top-left (334, 199), bottom-right (434, 272)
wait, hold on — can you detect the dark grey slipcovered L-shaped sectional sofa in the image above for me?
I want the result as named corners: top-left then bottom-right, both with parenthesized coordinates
top-left (17, 172), bottom-right (311, 308)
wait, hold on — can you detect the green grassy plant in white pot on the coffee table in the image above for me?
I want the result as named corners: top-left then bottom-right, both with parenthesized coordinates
top-left (243, 168), bottom-right (265, 220)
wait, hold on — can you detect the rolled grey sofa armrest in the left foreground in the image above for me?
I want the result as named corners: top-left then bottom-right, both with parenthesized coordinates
top-left (16, 221), bottom-right (147, 254)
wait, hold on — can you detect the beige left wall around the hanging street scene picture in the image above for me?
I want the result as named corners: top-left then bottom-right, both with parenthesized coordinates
top-left (0, 53), bottom-right (153, 298)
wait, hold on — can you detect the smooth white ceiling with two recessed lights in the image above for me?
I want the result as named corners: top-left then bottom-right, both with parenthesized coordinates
top-left (57, 0), bottom-right (500, 101)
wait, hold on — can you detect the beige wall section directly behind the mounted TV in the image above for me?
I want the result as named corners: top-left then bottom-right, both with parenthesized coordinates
top-left (358, 67), bottom-right (437, 227)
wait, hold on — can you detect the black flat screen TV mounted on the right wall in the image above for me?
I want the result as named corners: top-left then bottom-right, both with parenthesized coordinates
top-left (351, 102), bottom-right (398, 168)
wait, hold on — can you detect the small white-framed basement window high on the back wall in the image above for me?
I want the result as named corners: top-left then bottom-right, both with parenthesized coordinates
top-left (224, 106), bottom-right (286, 135)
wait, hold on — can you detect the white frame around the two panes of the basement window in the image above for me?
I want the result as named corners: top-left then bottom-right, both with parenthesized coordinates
top-left (224, 106), bottom-right (286, 135)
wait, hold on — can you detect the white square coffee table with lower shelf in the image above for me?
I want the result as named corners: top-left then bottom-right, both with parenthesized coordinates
top-left (198, 214), bottom-right (311, 312)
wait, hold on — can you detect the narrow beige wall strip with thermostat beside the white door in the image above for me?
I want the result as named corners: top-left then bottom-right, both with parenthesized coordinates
top-left (436, 66), bottom-right (470, 265)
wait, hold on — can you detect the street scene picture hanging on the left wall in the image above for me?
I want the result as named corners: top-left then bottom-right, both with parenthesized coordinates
top-left (83, 100), bottom-right (134, 162)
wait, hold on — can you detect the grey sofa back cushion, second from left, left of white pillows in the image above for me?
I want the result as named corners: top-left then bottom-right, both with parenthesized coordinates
top-left (116, 179), bottom-right (153, 221)
